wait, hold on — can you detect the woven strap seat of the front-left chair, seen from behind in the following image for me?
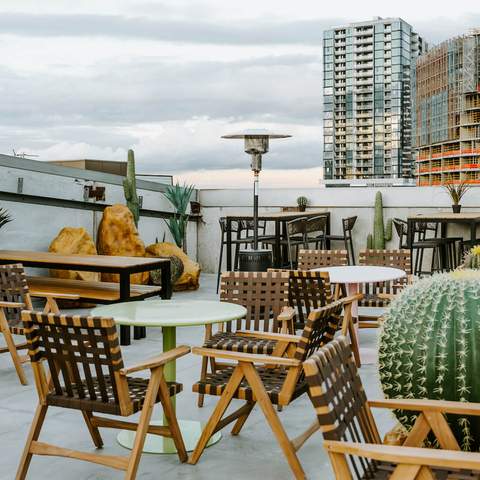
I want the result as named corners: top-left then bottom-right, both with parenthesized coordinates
top-left (47, 375), bottom-right (183, 415)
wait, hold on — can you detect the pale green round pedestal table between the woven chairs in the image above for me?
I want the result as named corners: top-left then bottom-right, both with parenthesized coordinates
top-left (92, 300), bottom-right (246, 453)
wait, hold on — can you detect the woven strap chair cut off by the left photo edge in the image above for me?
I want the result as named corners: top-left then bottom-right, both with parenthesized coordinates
top-left (0, 264), bottom-right (78, 385)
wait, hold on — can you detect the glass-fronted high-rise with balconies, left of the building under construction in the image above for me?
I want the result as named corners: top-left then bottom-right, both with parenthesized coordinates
top-left (323, 18), bottom-right (426, 184)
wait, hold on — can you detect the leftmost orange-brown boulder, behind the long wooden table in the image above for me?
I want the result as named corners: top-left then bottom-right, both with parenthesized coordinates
top-left (48, 227), bottom-right (100, 282)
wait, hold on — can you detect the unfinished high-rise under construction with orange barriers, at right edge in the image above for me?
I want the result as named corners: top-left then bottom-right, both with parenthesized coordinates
top-left (414, 30), bottom-right (480, 186)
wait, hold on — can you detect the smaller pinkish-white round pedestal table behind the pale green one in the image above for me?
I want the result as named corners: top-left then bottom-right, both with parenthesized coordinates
top-left (313, 265), bottom-right (407, 317)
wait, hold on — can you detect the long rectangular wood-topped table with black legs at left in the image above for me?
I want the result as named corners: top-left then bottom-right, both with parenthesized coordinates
top-left (0, 250), bottom-right (172, 345)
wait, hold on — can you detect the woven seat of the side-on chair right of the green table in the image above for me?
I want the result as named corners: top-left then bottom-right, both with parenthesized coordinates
top-left (192, 367), bottom-right (307, 404)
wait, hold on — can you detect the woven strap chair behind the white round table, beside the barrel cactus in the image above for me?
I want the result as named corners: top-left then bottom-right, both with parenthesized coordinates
top-left (358, 250), bottom-right (413, 328)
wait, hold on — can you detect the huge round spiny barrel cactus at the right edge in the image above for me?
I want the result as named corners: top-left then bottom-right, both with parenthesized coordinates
top-left (378, 270), bottom-right (480, 451)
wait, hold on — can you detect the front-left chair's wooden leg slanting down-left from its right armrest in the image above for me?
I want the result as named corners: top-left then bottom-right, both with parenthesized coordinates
top-left (125, 367), bottom-right (163, 480)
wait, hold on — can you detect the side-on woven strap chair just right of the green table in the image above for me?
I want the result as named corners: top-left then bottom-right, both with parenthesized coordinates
top-left (189, 301), bottom-right (343, 479)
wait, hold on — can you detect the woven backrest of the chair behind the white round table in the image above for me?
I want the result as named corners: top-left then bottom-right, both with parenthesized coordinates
top-left (359, 250), bottom-right (412, 295)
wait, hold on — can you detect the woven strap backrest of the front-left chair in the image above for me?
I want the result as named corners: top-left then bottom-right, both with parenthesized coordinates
top-left (22, 311), bottom-right (129, 411)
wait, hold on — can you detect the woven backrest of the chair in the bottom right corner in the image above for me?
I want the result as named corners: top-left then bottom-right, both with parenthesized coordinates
top-left (304, 337), bottom-right (380, 479)
